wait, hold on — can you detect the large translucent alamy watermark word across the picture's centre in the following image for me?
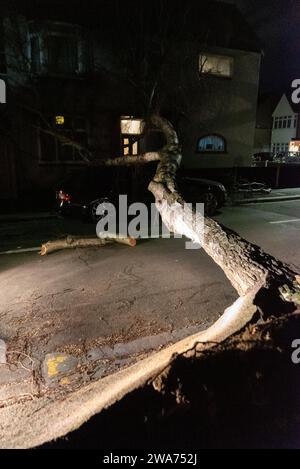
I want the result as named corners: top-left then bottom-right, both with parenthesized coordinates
top-left (96, 195), bottom-right (204, 249)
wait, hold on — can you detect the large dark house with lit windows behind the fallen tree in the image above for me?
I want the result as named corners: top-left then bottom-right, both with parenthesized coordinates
top-left (0, 0), bottom-right (261, 207)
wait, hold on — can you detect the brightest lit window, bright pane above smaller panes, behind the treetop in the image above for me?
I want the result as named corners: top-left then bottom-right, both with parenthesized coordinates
top-left (121, 117), bottom-right (144, 156)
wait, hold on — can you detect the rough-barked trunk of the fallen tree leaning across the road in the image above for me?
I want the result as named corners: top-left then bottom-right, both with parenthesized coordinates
top-left (149, 116), bottom-right (300, 314)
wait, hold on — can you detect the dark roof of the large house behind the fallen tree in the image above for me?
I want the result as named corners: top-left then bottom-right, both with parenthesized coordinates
top-left (5, 0), bottom-right (262, 52)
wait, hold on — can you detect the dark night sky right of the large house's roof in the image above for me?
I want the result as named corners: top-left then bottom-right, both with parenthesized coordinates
top-left (231, 0), bottom-right (300, 91)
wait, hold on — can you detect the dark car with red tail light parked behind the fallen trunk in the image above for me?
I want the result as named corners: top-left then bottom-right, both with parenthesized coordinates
top-left (56, 168), bottom-right (226, 221)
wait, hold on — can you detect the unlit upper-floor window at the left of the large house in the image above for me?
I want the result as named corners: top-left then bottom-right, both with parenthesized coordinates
top-left (28, 23), bottom-right (88, 75)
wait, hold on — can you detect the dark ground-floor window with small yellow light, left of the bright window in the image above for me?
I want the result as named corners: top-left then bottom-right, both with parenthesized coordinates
top-left (39, 115), bottom-right (88, 163)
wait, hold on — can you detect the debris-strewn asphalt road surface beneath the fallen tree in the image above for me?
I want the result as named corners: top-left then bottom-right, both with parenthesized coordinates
top-left (0, 197), bottom-right (300, 381)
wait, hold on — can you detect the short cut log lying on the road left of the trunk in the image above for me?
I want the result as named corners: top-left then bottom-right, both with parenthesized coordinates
top-left (40, 235), bottom-right (136, 256)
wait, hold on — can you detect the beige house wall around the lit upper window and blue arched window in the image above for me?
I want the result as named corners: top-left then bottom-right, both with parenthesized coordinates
top-left (170, 46), bottom-right (260, 168)
